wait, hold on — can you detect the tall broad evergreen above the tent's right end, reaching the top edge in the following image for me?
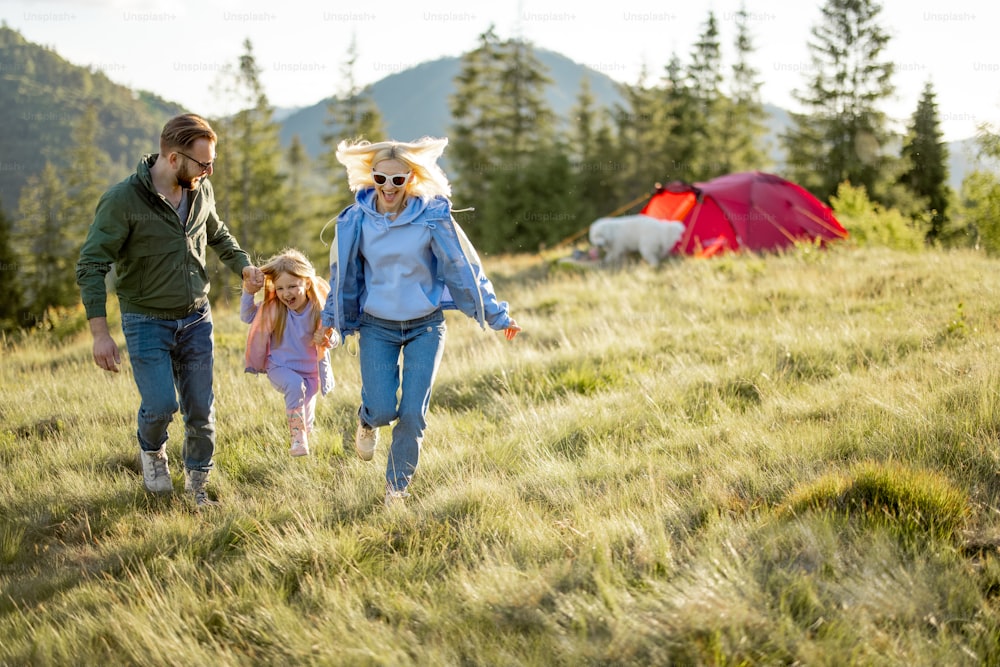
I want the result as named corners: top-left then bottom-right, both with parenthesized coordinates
top-left (782, 0), bottom-right (895, 203)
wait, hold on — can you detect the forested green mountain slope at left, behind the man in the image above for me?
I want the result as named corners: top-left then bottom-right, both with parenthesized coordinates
top-left (0, 25), bottom-right (184, 214)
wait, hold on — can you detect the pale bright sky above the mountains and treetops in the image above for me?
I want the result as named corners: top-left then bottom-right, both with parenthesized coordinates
top-left (0, 0), bottom-right (1000, 141)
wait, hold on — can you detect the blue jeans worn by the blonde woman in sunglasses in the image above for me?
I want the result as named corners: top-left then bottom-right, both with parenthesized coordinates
top-left (358, 310), bottom-right (446, 491)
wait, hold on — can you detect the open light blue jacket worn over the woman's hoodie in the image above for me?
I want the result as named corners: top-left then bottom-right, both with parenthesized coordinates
top-left (322, 188), bottom-right (511, 337)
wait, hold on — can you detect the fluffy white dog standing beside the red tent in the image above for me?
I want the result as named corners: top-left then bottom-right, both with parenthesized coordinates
top-left (590, 214), bottom-right (684, 266)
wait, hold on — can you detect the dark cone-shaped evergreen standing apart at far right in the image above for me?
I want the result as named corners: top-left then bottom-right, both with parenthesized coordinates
top-left (900, 81), bottom-right (950, 242)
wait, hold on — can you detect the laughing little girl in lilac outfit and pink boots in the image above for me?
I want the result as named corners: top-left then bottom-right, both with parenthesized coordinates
top-left (240, 248), bottom-right (334, 456)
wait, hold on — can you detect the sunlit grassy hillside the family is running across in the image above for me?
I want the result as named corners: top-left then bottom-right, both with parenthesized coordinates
top-left (0, 246), bottom-right (1000, 665)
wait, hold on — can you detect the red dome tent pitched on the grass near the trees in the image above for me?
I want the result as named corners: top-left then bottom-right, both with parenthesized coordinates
top-left (640, 171), bottom-right (847, 257)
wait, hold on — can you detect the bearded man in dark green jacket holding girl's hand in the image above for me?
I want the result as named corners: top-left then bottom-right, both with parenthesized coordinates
top-left (76, 114), bottom-right (264, 506)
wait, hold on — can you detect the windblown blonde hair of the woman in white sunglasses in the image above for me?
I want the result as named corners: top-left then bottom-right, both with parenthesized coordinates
top-left (337, 137), bottom-right (451, 198)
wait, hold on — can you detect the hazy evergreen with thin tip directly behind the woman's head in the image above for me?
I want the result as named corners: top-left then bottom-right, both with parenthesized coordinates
top-left (320, 36), bottom-right (384, 216)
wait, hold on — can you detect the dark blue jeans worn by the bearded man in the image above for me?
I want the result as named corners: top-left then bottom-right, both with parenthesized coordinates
top-left (122, 304), bottom-right (215, 472)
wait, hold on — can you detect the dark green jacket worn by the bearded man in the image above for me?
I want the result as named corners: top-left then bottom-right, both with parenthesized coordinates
top-left (76, 154), bottom-right (251, 319)
